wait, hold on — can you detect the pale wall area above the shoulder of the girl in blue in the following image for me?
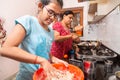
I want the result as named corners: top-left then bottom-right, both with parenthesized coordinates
top-left (0, 0), bottom-right (37, 33)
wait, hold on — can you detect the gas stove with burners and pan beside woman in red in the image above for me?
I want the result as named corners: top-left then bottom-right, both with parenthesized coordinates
top-left (76, 41), bottom-right (117, 60)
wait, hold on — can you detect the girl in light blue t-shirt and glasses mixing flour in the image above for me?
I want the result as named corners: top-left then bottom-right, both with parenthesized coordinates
top-left (0, 0), bottom-right (63, 80)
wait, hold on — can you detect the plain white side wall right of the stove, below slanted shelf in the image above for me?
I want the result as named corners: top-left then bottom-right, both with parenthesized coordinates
top-left (97, 7), bottom-right (120, 54)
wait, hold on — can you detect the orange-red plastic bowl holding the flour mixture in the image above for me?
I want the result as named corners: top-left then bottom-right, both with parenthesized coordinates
top-left (33, 63), bottom-right (84, 80)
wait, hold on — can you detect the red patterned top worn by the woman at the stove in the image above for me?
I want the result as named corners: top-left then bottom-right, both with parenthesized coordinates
top-left (51, 22), bottom-right (72, 58)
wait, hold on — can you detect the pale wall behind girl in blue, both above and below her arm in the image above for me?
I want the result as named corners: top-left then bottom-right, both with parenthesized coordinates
top-left (0, 0), bottom-right (37, 80)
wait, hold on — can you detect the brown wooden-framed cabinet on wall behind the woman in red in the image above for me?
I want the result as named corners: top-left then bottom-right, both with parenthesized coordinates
top-left (62, 7), bottom-right (83, 36)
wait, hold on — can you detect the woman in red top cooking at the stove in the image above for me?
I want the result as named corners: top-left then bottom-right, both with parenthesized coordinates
top-left (51, 10), bottom-right (80, 59)
